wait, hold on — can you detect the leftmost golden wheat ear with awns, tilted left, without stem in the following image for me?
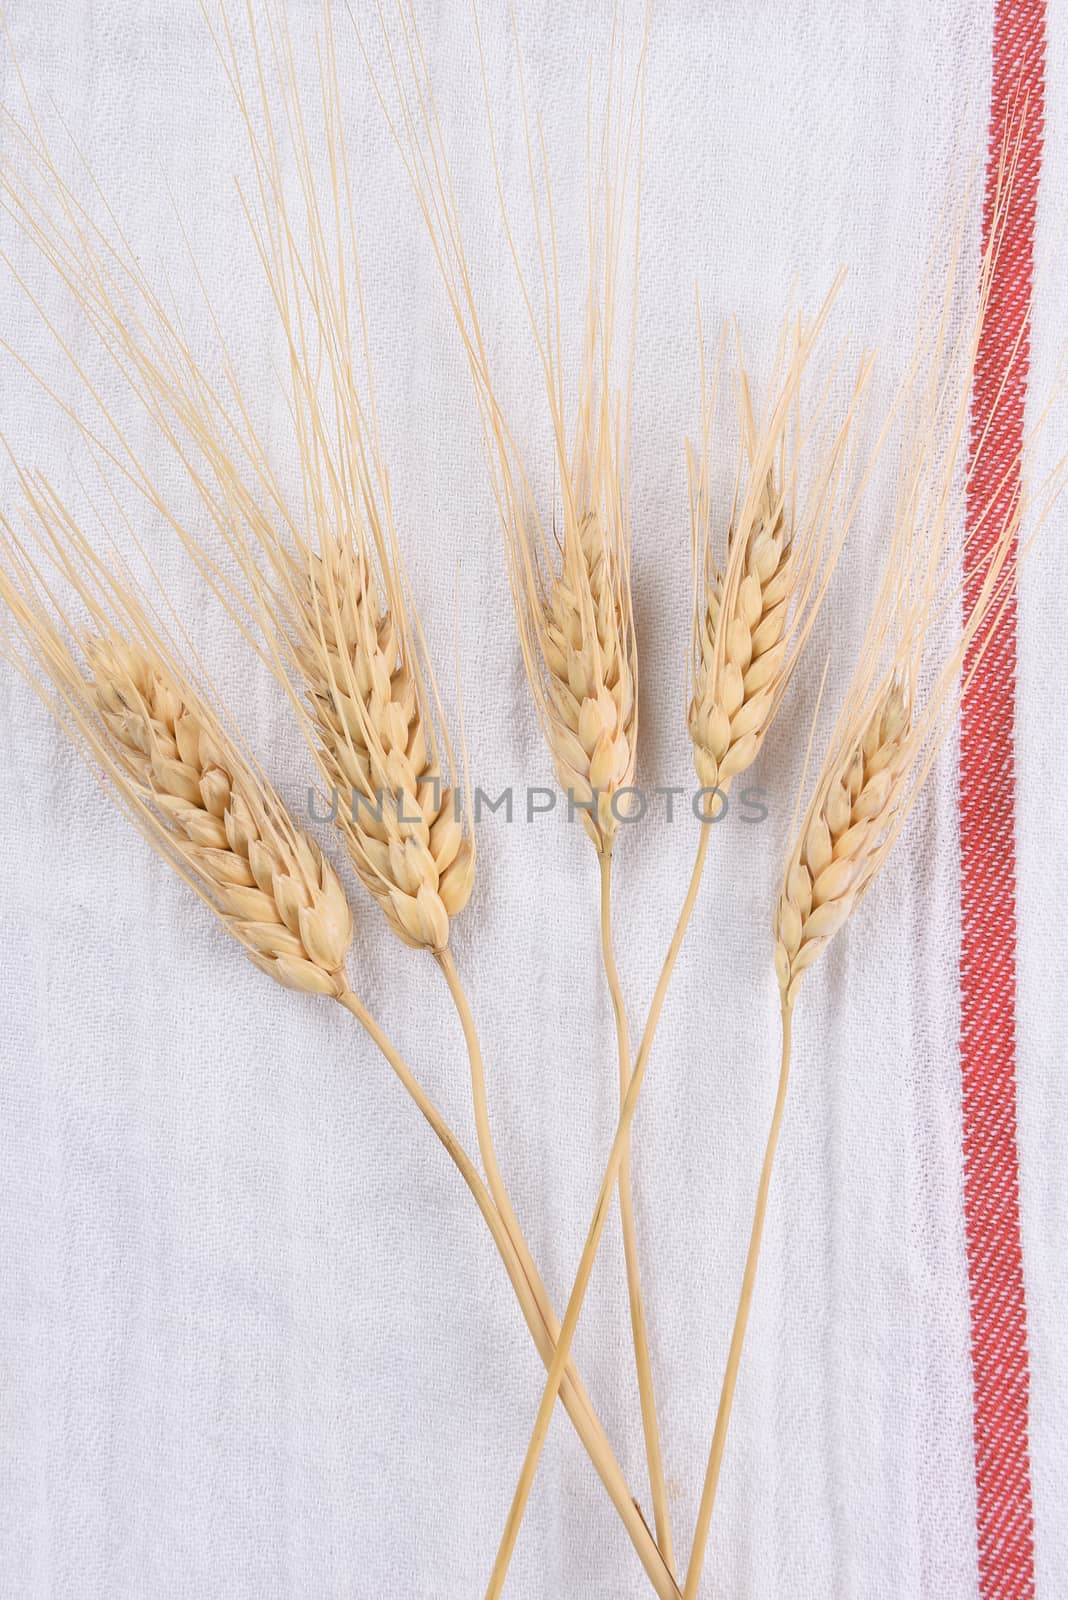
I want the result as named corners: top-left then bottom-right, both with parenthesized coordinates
top-left (0, 472), bottom-right (352, 998)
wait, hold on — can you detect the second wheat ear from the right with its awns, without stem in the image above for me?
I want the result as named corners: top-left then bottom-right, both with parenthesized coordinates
top-left (687, 286), bottom-right (871, 790)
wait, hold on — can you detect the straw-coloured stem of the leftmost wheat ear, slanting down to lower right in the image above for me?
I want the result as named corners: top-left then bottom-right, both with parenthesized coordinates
top-left (339, 990), bottom-right (681, 1600)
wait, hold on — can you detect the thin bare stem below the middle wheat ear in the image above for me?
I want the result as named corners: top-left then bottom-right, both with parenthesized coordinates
top-left (598, 851), bottom-right (675, 1573)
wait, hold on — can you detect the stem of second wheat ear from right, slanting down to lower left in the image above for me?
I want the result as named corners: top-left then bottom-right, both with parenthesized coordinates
top-left (486, 822), bottom-right (710, 1600)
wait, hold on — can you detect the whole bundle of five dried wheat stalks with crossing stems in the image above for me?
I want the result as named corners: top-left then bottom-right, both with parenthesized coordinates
top-left (0, 12), bottom-right (1065, 1600)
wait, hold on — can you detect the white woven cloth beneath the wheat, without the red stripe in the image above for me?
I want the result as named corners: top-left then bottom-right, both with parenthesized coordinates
top-left (0, 0), bottom-right (1068, 1600)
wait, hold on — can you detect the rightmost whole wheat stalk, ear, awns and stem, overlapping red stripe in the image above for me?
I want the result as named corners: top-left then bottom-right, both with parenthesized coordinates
top-left (684, 140), bottom-right (1066, 1600)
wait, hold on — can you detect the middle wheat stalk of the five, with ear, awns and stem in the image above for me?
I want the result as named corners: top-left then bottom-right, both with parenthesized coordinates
top-left (365, 15), bottom-right (675, 1594)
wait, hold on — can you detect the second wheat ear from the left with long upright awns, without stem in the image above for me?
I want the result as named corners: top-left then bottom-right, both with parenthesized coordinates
top-left (187, 3), bottom-right (475, 954)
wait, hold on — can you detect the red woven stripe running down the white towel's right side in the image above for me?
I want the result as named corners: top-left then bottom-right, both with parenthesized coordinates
top-left (959, 0), bottom-right (1046, 1600)
